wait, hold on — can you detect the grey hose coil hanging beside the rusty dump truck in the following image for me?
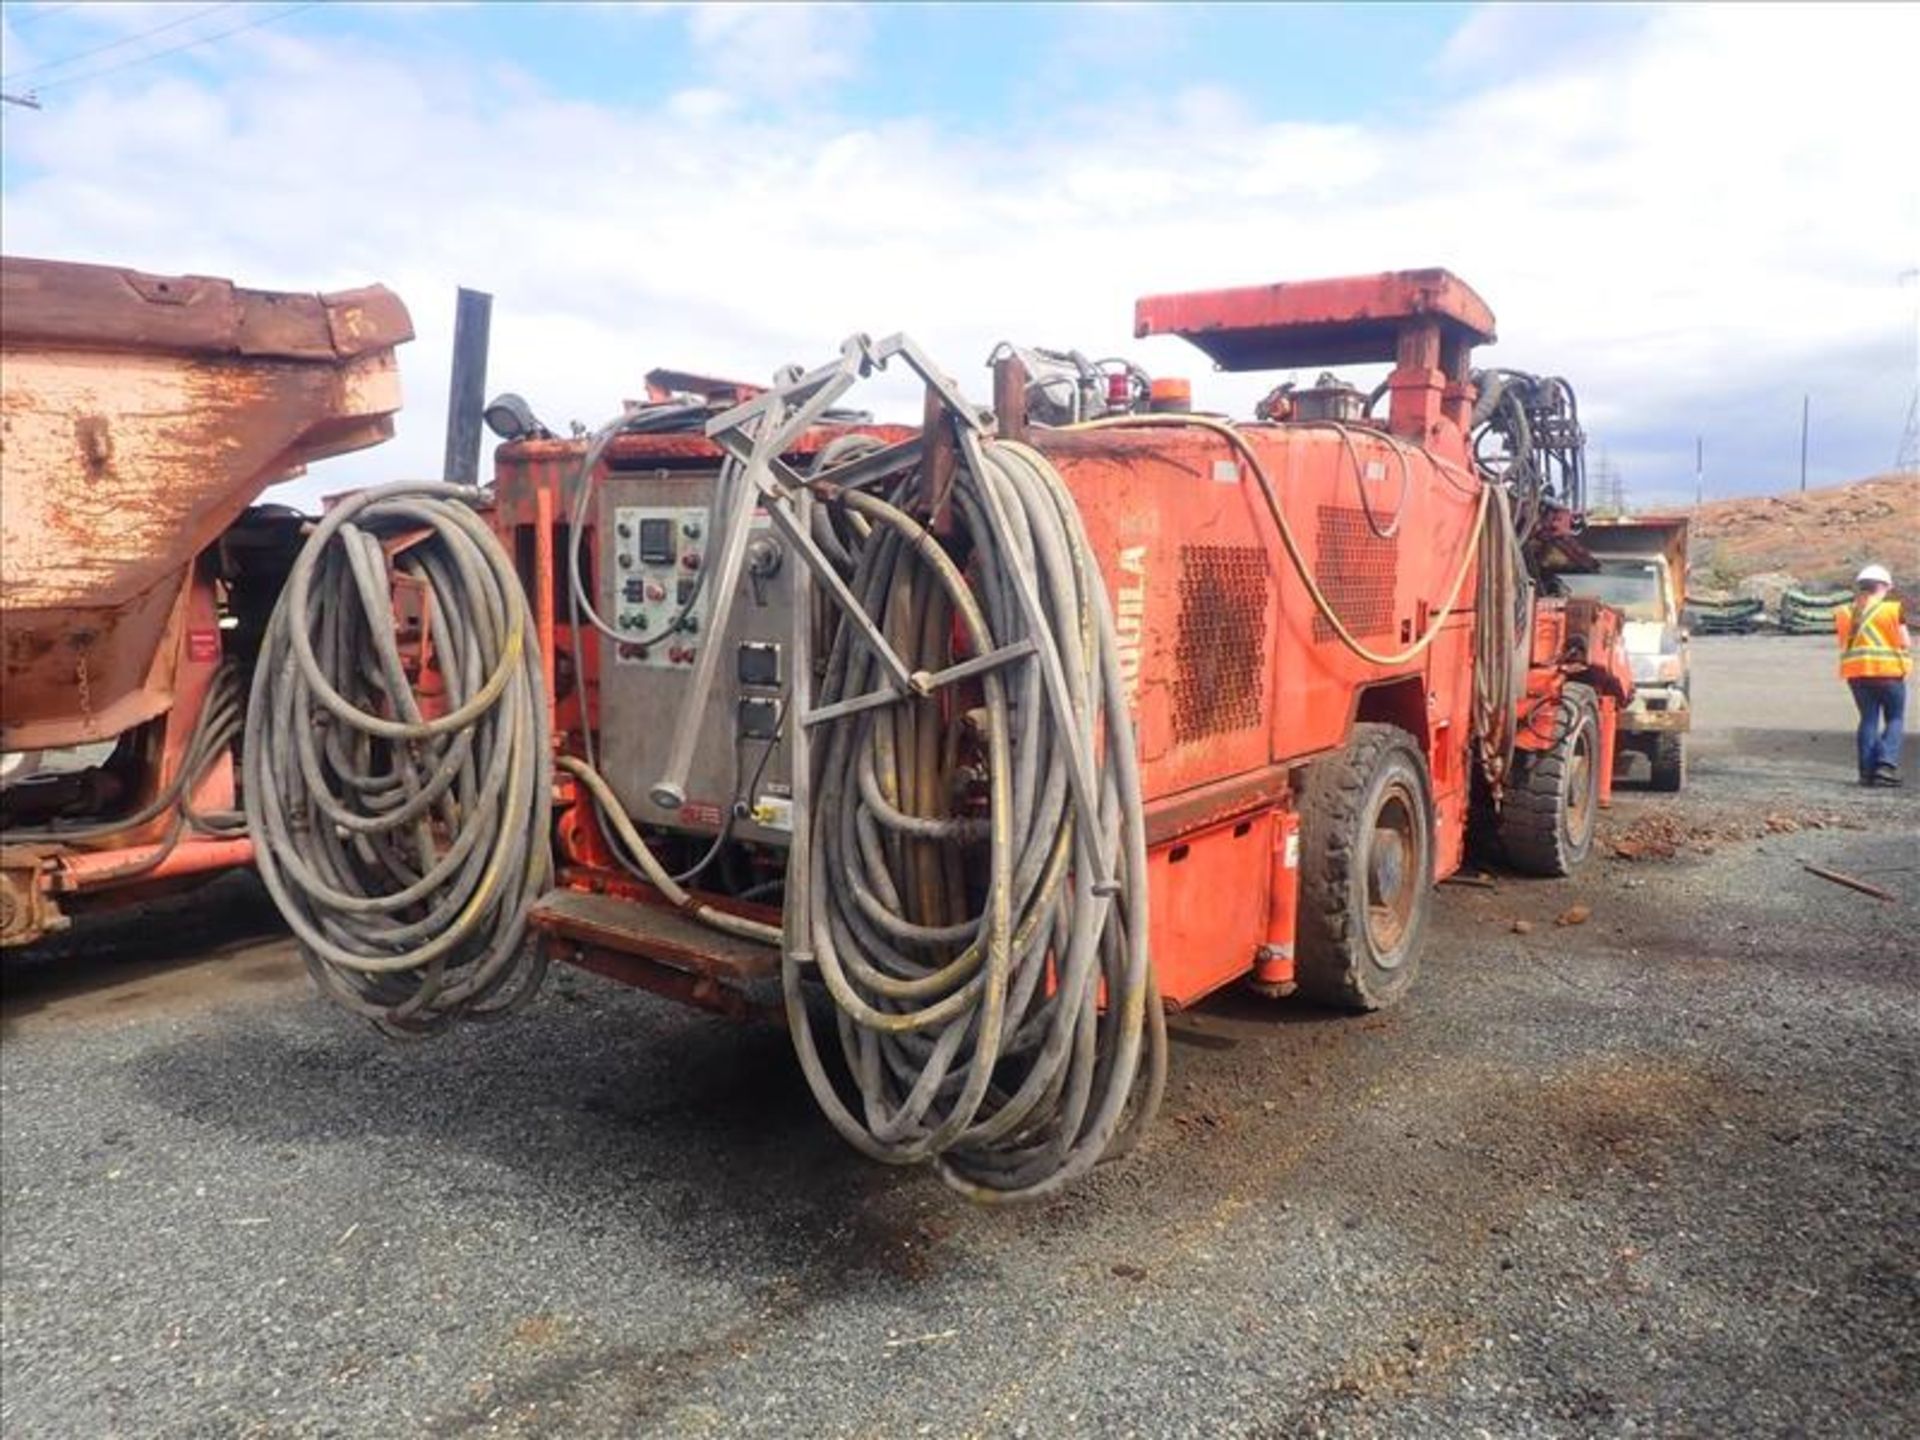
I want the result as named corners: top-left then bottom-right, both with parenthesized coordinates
top-left (244, 484), bottom-right (551, 1033)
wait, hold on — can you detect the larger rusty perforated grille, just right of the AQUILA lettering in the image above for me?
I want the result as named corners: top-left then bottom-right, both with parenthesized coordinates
top-left (1173, 545), bottom-right (1267, 745)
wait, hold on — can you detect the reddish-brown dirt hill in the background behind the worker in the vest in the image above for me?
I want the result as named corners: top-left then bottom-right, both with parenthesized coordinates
top-left (1692, 474), bottom-right (1920, 591)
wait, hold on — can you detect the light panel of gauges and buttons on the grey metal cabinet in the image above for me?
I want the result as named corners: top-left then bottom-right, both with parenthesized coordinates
top-left (612, 505), bottom-right (710, 668)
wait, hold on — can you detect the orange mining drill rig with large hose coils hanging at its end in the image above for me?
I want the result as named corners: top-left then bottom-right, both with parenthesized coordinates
top-left (244, 271), bottom-right (1632, 1198)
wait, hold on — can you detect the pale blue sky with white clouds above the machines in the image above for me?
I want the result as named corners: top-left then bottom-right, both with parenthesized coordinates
top-left (0, 0), bottom-right (1920, 505)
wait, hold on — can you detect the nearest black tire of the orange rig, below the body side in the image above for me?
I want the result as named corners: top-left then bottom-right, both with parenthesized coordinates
top-left (1294, 724), bottom-right (1434, 1010)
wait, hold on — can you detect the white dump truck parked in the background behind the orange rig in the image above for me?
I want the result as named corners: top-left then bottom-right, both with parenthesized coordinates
top-left (1555, 515), bottom-right (1689, 791)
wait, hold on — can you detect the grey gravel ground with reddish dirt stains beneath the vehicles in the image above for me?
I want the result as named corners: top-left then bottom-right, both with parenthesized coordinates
top-left (0, 639), bottom-right (1920, 1440)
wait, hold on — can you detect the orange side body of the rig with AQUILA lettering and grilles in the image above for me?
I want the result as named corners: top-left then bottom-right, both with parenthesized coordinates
top-left (1035, 424), bottom-right (1480, 1004)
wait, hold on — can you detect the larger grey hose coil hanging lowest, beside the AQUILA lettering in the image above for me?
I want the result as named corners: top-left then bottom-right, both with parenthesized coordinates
top-left (783, 436), bottom-right (1167, 1200)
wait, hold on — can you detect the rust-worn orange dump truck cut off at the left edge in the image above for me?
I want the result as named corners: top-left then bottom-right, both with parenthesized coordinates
top-left (0, 257), bottom-right (413, 947)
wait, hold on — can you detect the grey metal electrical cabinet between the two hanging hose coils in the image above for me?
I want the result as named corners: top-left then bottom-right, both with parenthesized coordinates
top-left (593, 468), bottom-right (793, 845)
